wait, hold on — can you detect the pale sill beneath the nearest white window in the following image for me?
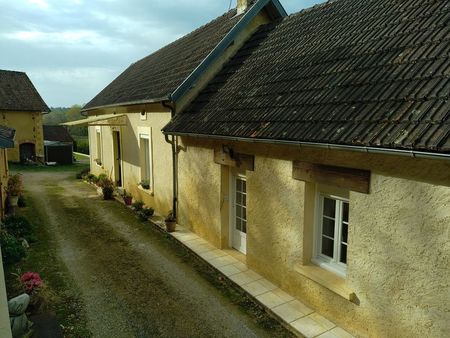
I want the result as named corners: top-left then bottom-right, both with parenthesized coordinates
top-left (294, 264), bottom-right (358, 304)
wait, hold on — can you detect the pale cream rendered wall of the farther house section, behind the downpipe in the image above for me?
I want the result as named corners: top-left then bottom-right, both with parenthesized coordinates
top-left (89, 111), bottom-right (172, 215)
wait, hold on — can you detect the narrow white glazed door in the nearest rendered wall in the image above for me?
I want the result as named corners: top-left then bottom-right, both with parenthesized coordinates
top-left (230, 175), bottom-right (247, 254)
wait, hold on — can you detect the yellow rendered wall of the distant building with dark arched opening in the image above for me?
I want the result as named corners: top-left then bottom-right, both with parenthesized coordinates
top-left (1, 111), bottom-right (44, 162)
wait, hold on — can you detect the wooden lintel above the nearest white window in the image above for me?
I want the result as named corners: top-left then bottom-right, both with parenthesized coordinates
top-left (292, 161), bottom-right (370, 194)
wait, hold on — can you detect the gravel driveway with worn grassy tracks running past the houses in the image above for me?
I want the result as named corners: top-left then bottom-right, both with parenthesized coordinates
top-left (24, 172), bottom-right (291, 338)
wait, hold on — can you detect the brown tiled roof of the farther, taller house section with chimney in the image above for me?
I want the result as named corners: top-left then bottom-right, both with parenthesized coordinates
top-left (84, 9), bottom-right (239, 110)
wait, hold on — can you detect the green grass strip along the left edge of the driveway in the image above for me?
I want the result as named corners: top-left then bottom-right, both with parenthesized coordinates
top-left (5, 199), bottom-right (92, 337)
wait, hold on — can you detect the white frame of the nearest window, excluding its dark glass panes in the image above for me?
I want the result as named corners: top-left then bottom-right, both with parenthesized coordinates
top-left (312, 190), bottom-right (350, 278)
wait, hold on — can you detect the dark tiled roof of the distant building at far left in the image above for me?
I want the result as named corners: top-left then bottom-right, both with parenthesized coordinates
top-left (0, 70), bottom-right (50, 112)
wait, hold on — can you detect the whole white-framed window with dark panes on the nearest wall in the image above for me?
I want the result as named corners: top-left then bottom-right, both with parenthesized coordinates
top-left (313, 192), bottom-right (349, 277)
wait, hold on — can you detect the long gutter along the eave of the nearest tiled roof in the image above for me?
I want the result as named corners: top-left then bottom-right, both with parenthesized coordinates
top-left (163, 131), bottom-right (450, 160)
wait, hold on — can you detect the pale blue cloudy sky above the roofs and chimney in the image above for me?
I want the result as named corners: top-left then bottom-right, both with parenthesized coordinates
top-left (0, 0), bottom-right (324, 107)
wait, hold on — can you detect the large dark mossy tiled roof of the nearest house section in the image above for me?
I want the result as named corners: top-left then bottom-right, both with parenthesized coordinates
top-left (164, 0), bottom-right (450, 152)
